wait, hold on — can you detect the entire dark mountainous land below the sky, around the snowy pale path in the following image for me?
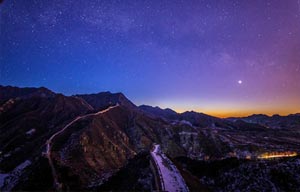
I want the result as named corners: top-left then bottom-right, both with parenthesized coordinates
top-left (0, 86), bottom-right (300, 191)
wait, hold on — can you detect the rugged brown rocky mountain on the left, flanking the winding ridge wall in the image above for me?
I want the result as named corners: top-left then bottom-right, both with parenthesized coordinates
top-left (0, 87), bottom-right (184, 190)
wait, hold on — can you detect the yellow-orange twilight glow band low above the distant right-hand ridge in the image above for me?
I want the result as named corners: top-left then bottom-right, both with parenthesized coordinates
top-left (140, 99), bottom-right (300, 118)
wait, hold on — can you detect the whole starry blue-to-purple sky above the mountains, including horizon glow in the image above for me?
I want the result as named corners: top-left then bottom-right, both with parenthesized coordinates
top-left (0, 0), bottom-right (300, 117)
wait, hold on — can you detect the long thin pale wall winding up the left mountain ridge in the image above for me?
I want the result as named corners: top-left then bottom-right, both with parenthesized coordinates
top-left (46, 104), bottom-right (119, 189)
